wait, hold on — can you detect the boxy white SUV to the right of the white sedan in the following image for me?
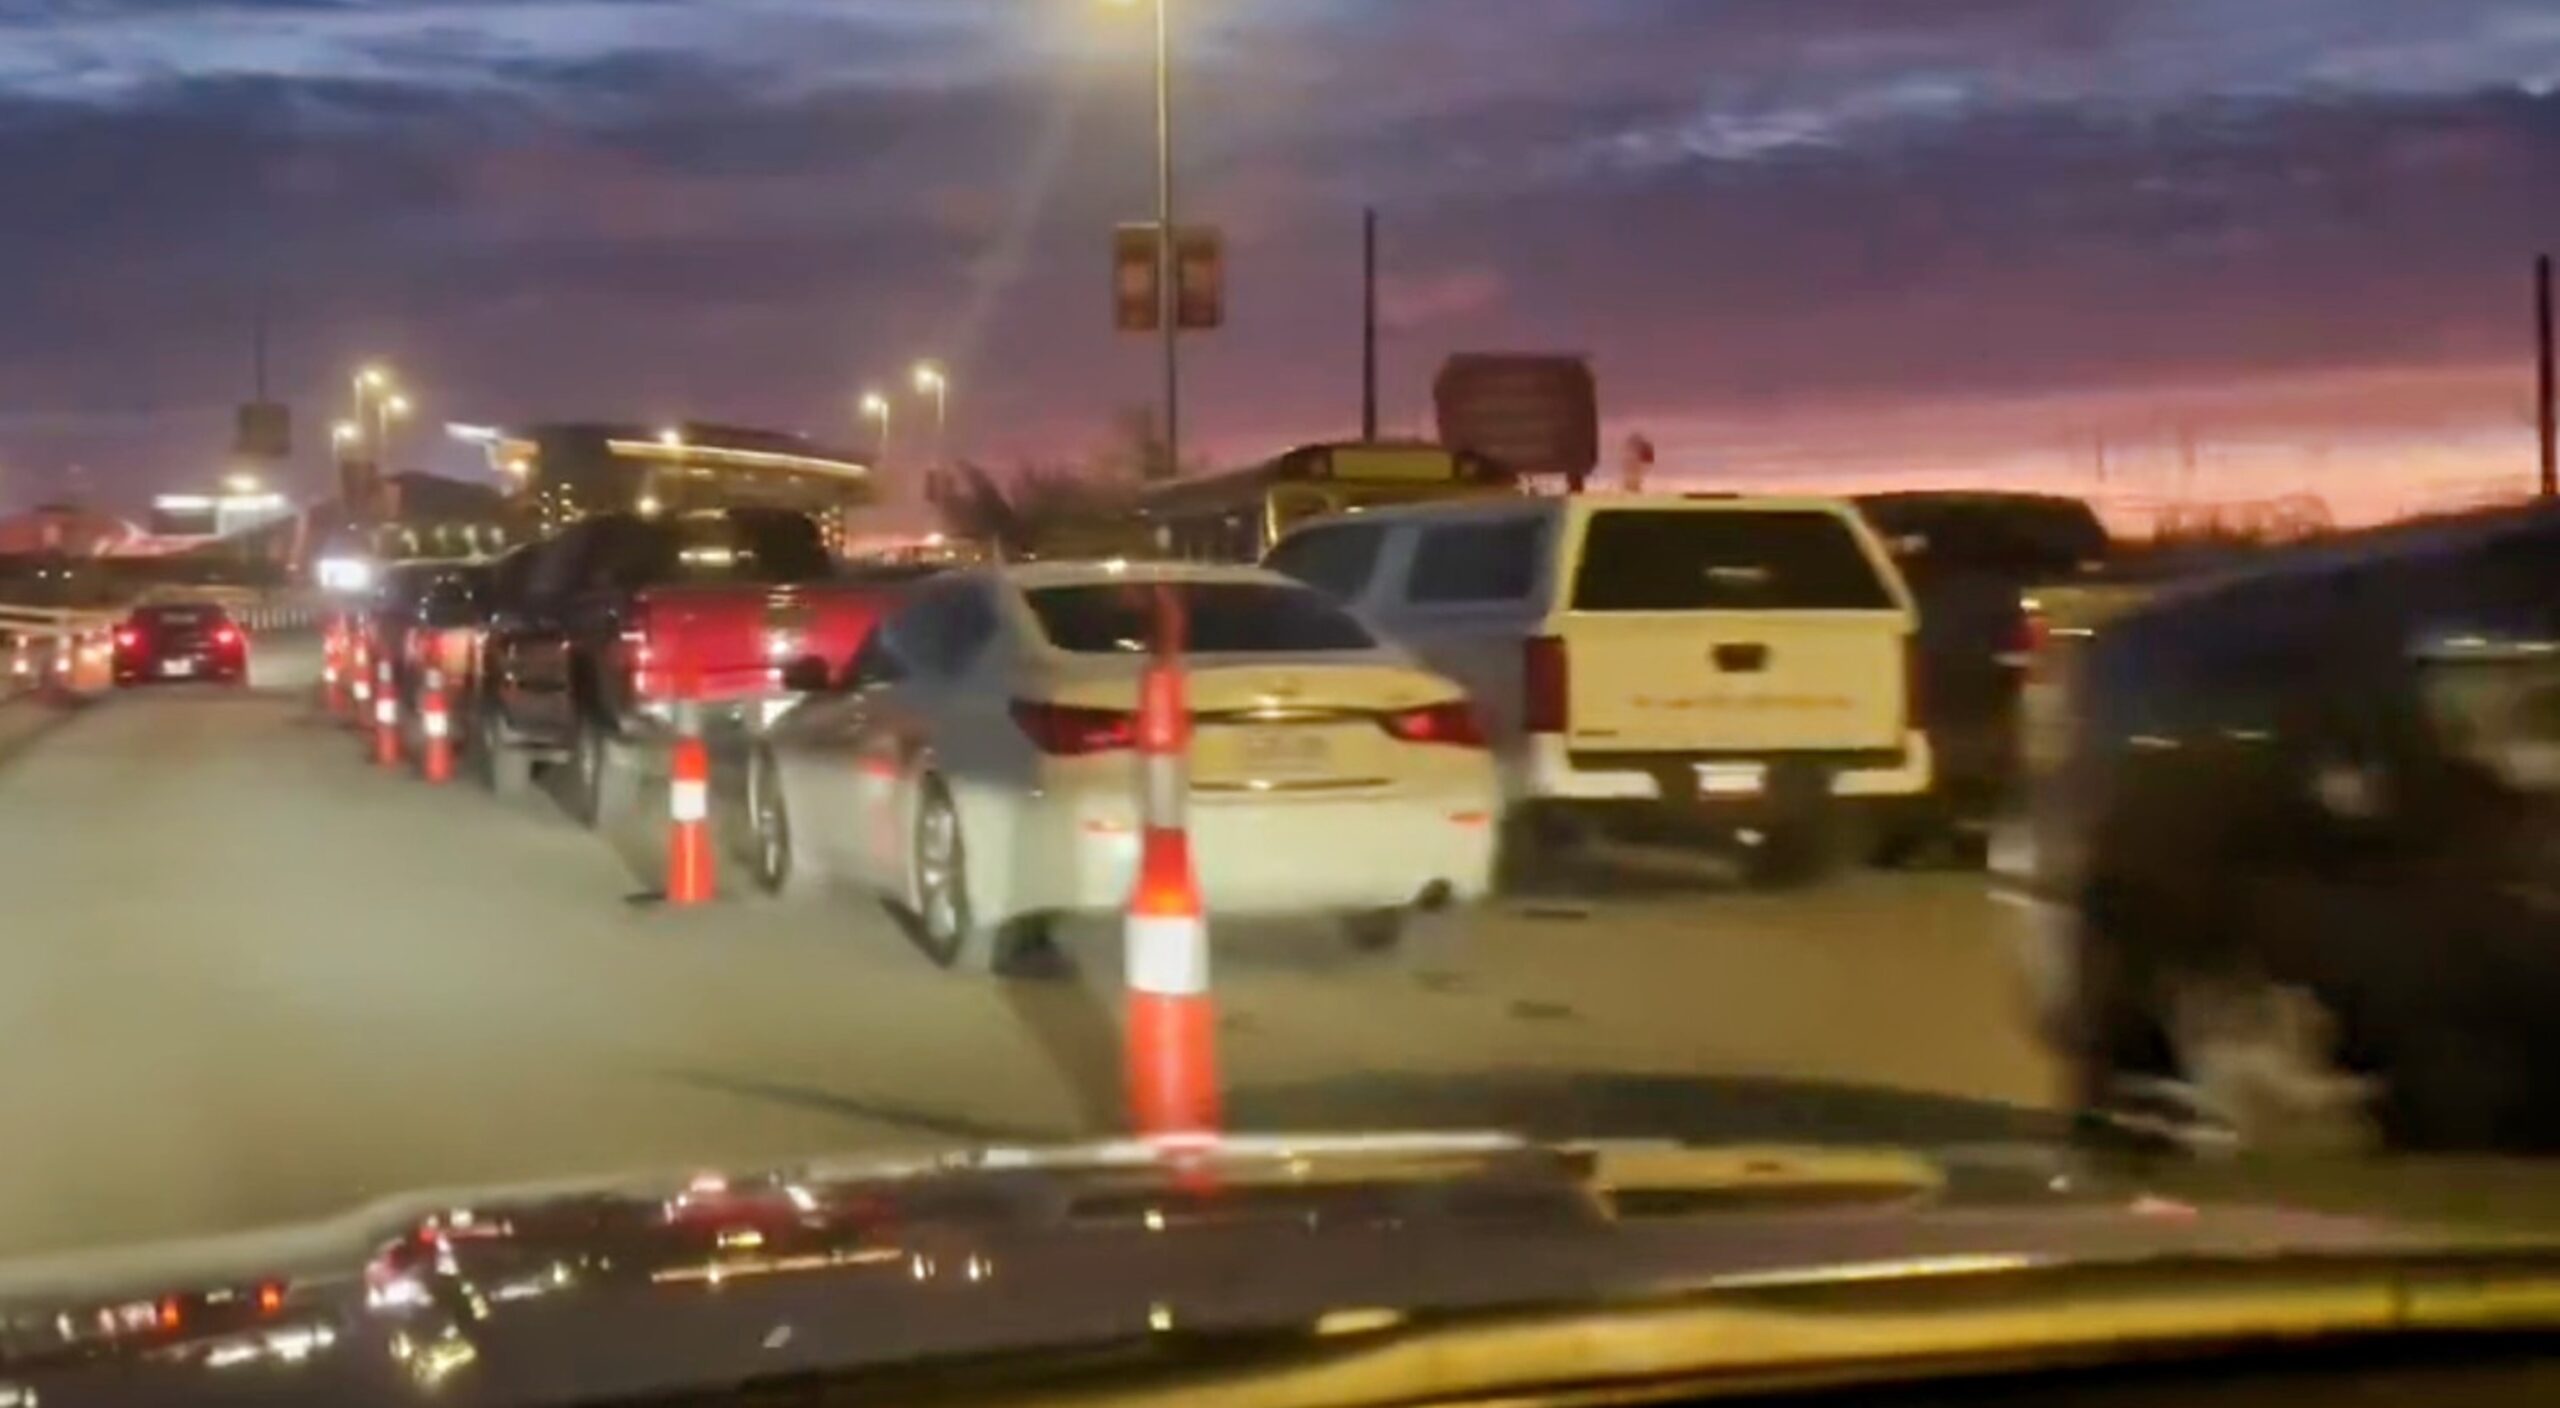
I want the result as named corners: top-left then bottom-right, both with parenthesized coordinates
top-left (1265, 497), bottom-right (1930, 883)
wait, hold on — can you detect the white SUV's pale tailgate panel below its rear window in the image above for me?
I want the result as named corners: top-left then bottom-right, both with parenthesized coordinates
top-left (1564, 612), bottom-right (1907, 753)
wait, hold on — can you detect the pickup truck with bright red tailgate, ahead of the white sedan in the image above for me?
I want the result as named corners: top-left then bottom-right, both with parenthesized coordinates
top-left (468, 507), bottom-right (893, 824)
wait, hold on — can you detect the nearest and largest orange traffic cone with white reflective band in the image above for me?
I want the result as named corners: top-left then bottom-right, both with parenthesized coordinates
top-left (1121, 591), bottom-right (1219, 1139)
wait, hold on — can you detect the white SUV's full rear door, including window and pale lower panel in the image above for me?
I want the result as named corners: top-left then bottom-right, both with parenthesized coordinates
top-left (1556, 502), bottom-right (1915, 753)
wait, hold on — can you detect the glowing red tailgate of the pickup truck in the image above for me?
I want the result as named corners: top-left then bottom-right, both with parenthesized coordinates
top-left (635, 584), bottom-right (891, 699)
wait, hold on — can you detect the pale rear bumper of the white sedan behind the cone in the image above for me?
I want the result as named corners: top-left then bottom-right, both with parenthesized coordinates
top-left (1001, 786), bottom-right (1498, 916)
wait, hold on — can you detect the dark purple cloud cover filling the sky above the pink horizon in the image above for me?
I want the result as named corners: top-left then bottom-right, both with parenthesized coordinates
top-left (0, 0), bottom-right (2560, 506)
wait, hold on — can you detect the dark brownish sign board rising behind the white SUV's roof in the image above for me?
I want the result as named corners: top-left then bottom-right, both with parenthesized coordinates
top-left (1431, 353), bottom-right (1600, 494)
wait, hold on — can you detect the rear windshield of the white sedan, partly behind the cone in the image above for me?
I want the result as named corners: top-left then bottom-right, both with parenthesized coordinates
top-left (1027, 581), bottom-right (1375, 655)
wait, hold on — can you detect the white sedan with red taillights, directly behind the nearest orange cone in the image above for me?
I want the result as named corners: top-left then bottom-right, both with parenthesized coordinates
top-left (742, 563), bottom-right (1500, 968)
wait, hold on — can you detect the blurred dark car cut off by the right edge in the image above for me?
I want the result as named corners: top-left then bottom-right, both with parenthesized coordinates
top-left (1999, 509), bottom-right (2560, 1149)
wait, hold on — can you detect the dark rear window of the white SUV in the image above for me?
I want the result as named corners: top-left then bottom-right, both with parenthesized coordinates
top-left (1572, 509), bottom-right (1894, 612)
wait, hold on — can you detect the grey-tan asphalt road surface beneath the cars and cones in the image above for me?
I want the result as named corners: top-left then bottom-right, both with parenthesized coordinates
top-left (0, 640), bottom-right (2053, 1254)
